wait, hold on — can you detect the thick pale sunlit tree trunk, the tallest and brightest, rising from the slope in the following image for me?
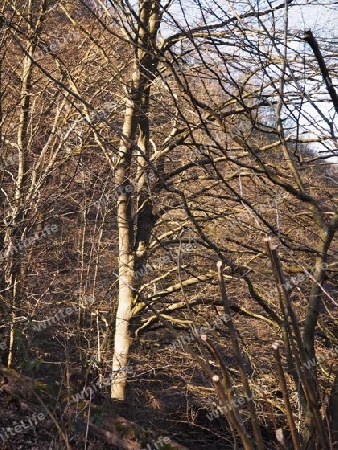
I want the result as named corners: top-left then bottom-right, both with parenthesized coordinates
top-left (111, 0), bottom-right (160, 400)
